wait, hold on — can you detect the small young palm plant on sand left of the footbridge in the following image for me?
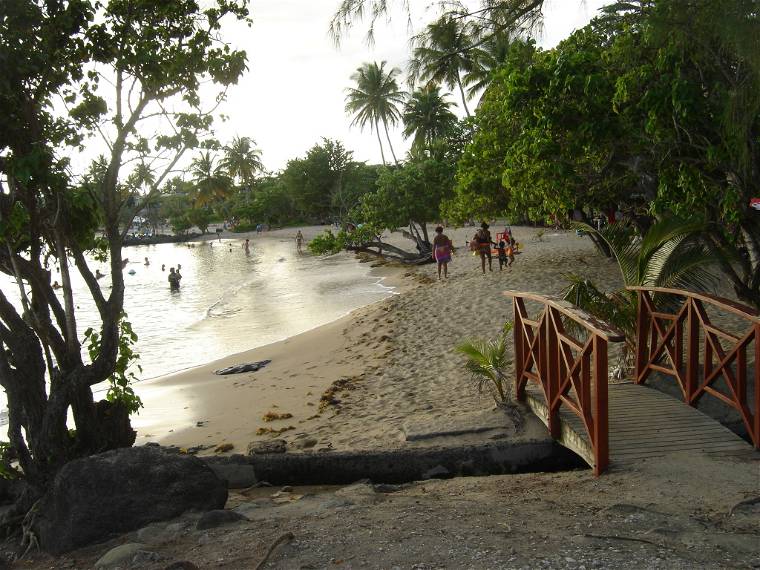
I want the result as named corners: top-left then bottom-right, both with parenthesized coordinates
top-left (456, 321), bottom-right (514, 405)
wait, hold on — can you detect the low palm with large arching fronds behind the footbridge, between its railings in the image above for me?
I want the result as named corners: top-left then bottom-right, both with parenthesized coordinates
top-left (563, 218), bottom-right (716, 358)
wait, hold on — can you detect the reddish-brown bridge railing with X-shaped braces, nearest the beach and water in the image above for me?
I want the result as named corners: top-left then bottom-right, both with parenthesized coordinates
top-left (504, 291), bottom-right (625, 475)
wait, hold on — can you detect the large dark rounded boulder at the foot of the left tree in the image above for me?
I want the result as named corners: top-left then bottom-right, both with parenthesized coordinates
top-left (35, 447), bottom-right (227, 554)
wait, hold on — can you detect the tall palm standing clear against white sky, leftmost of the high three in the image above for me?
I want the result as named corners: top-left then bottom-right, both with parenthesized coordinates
top-left (346, 61), bottom-right (404, 164)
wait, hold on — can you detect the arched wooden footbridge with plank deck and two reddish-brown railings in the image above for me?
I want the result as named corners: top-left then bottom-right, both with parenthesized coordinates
top-left (504, 287), bottom-right (760, 475)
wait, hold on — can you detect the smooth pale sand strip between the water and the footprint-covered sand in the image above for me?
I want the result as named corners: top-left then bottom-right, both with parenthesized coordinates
top-left (132, 258), bottom-right (406, 453)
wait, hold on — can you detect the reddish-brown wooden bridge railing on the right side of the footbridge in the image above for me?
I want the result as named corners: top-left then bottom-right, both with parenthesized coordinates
top-left (628, 287), bottom-right (760, 449)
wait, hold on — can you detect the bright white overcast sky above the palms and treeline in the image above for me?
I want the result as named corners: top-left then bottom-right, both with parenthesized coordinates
top-left (212, 0), bottom-right (609, 171)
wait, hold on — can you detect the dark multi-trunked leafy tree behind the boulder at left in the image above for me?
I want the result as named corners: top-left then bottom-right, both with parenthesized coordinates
top-left (0, 0), bottom-right (247, 516)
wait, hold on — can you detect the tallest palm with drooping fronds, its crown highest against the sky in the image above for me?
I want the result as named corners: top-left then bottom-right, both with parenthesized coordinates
top-left (409, 15), bottom-right (475, 117)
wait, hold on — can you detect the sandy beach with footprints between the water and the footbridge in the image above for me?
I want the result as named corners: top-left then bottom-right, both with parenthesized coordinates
top-left (134, 225), bottom-right (621, 454)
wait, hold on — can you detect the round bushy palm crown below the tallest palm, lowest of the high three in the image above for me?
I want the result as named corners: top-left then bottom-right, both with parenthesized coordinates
top-left (403, 85), bottom-right (457, 149)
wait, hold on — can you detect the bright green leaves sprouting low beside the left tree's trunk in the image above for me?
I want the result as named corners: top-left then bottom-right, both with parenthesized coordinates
top-left (84, 311), bottom-right (143, 414)
